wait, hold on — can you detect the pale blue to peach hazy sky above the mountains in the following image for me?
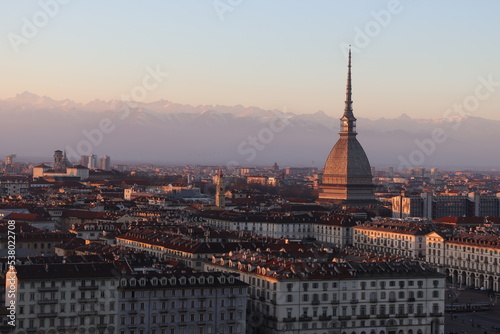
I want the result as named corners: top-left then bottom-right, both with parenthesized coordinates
top-left (0, 0), bottom-right (500, 119)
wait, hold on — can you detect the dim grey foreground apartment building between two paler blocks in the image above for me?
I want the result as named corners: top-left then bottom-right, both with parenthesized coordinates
top-left (117, 272), bottom-right (247, 334)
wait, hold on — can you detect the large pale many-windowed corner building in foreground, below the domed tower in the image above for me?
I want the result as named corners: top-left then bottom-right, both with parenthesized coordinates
top-left (206, 258), bottom-right (445, 334)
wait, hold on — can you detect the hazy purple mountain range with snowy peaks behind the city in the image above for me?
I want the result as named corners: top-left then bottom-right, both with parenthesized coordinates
top-left (0, 92), bottom-right (500, 169)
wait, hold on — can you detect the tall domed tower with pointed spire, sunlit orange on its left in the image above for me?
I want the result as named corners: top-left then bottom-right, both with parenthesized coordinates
top-left (319, 49), bottom-right (375, 206)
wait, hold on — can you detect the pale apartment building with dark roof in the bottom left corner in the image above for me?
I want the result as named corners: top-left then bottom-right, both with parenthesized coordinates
top-left (11, 263), bottom-right (118, 334)
